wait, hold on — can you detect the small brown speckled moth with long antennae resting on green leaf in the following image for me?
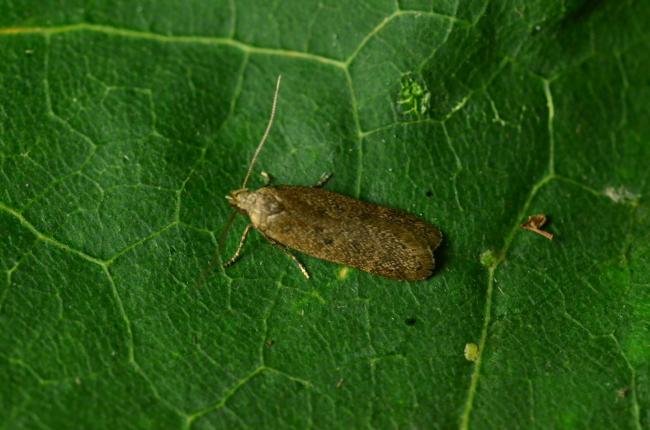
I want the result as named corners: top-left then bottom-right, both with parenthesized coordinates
top-left (225, 77), bottom-right (442, 281)
